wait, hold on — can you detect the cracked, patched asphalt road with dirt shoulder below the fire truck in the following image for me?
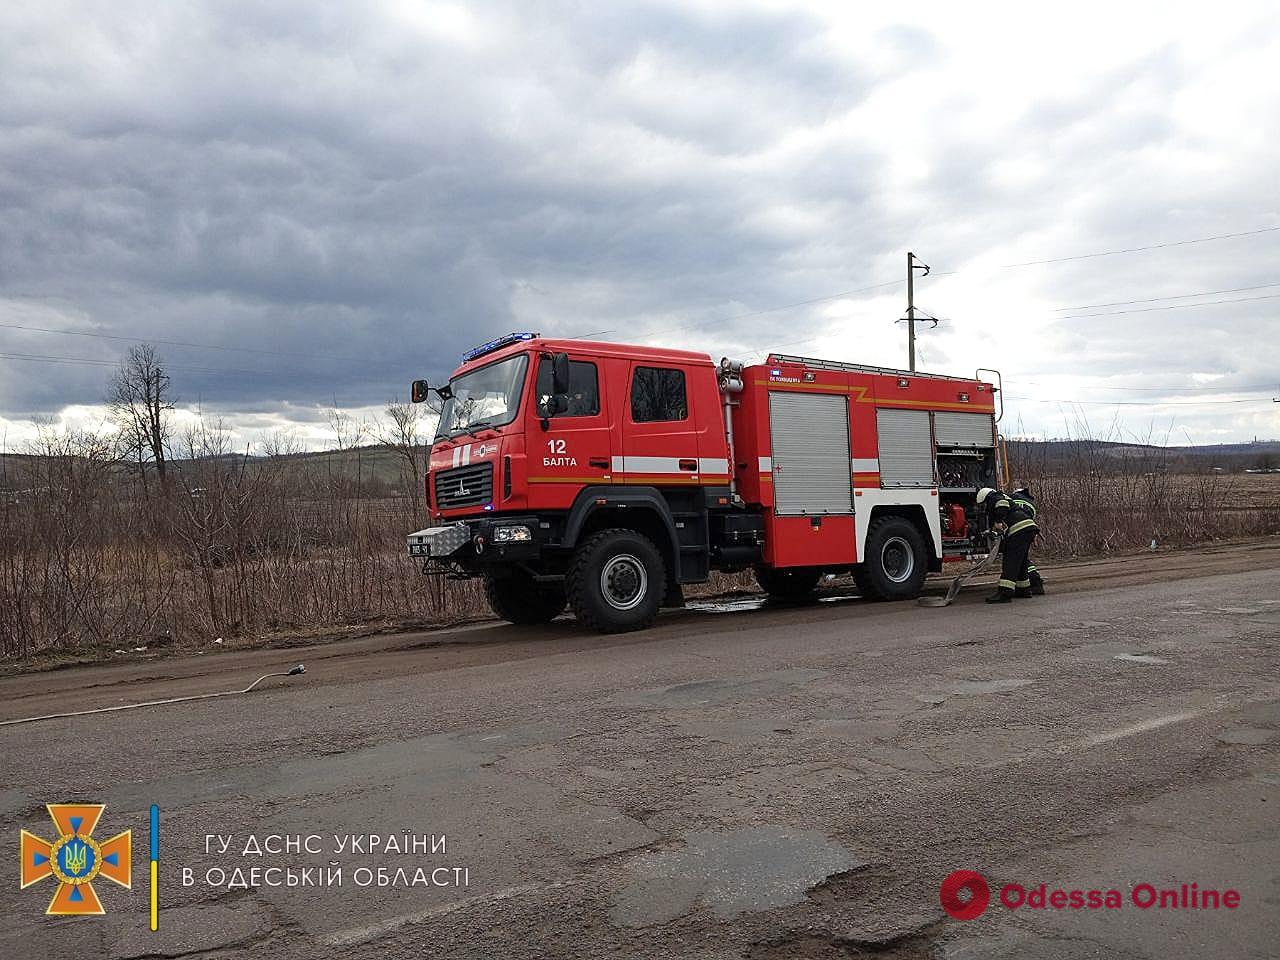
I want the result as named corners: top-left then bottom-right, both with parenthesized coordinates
top-left (0, 549), bottom-right (1280, 960)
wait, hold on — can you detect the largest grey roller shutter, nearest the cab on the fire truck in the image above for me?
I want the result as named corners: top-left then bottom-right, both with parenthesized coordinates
top-left (769, 393), bottom-right (854, 516)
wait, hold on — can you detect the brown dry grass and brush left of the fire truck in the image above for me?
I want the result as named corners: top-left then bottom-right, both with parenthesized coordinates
top-left (0, 430), bottom-right (483, 658)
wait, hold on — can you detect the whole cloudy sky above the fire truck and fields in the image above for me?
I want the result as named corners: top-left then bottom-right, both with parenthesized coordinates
top-left (0, 0), bottom-right (1280, 449)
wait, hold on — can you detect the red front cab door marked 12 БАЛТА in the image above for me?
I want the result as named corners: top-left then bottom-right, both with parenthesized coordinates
top-left (525, 353), bottom-right (614, 509)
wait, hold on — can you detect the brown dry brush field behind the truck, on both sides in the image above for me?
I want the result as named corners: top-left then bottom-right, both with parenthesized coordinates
top-left (0, 433), bottom-right (1280, 660)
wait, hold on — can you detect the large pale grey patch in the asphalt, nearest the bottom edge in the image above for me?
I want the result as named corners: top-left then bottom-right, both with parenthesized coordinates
top-left (609, 827), bottom-right (864, 927)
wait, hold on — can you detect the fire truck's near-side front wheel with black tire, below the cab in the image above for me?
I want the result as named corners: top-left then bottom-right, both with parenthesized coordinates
top-left (564, 527), bottom-right (667, 634)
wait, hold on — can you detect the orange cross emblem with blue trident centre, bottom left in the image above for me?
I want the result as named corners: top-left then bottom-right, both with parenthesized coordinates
top-left (22, 804), bottom-right (133, 916)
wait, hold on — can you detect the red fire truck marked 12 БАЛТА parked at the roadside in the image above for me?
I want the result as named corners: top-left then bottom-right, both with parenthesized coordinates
top-left (408, 333), bottom-right (1000, 632)
